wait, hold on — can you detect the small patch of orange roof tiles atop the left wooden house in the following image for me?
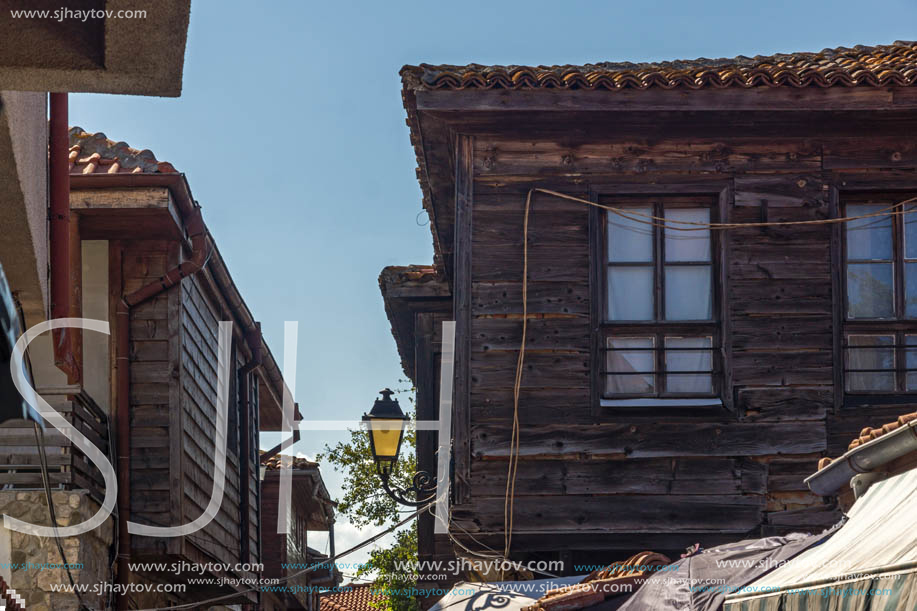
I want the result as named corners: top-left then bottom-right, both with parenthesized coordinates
top-left (70, 127), bottom-right (177, 174)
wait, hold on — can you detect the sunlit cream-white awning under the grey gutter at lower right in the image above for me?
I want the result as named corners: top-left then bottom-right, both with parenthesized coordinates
top-left (725, 469), bottom-right (917, 611)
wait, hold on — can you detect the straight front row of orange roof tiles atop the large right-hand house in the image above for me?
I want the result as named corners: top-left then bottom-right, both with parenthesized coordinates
top-left (401, 41), bottom-right (917, 90)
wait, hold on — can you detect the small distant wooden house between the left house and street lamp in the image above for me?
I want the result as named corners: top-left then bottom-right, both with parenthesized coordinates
top-left (261, 454), bottom-right (341, 611)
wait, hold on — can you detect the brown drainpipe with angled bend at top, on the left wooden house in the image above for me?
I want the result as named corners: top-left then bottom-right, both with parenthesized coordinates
top-left (115, 207), bottom-right (212, 610)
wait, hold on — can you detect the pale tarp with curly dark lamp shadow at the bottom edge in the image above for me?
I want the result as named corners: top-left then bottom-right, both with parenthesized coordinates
top-left (430, 575), bottom-right (585, 611)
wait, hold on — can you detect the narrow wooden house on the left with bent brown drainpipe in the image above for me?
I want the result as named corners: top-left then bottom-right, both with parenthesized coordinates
top-left (59, 128), bottom-right (296, 607)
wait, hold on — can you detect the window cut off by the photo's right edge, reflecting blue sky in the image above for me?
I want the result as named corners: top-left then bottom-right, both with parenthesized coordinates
top-left (843, 195), bottom-right (917, 394)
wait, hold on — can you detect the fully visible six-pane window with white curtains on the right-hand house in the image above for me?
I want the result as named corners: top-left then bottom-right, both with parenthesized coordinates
top-left (603, 198), bottom-right (719, 399)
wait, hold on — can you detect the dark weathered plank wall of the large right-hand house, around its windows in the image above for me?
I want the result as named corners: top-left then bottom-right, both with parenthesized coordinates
top-left (453, 136), bottom-right (913, 550)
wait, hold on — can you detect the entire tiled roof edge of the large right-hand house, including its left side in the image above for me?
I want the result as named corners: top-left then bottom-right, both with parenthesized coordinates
top-left (400, 41), bottom-right (917, 274)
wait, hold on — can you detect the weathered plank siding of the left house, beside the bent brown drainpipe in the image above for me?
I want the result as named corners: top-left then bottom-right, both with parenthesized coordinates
top-left (121, 241), bottom-right (260, 564)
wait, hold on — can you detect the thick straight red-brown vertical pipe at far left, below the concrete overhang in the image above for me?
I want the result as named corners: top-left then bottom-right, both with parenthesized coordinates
top-left (48, 93), bottom-right (80, 384)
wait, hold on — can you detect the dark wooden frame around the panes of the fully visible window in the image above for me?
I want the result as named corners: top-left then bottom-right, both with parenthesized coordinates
top-left (592, 194), bottom-right (727, 409)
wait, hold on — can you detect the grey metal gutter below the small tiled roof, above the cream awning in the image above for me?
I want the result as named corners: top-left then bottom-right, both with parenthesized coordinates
top-left (805, 420), bottom-right (917, 496)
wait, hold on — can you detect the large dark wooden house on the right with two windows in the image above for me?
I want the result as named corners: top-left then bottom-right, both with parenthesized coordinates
top-left (381, 42), bottom-right (917, 571)
